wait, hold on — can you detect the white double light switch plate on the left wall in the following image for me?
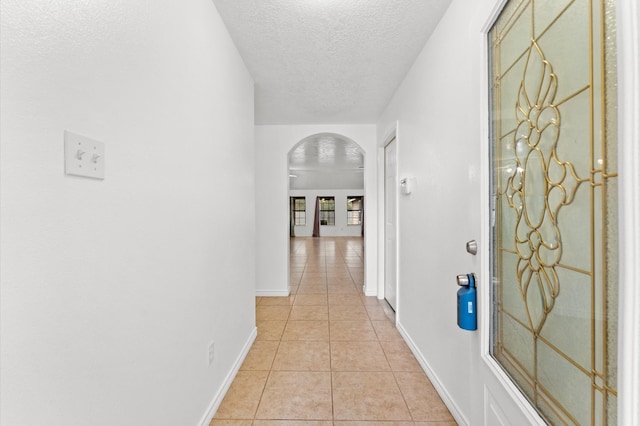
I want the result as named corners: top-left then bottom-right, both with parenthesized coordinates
top-left (64, 130), bottom-right (104, 179)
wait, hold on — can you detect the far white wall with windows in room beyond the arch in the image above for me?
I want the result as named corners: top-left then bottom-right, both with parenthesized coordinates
top-left (289, 189), bottom-right (364, 237)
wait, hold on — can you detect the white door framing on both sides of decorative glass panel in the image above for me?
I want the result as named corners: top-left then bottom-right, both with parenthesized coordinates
top-left (479, 0), bottom-right (640, 425)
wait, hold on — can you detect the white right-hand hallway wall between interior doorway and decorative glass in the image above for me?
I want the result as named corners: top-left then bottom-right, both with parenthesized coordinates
top-left (378, 0), bottom-right (487, 424)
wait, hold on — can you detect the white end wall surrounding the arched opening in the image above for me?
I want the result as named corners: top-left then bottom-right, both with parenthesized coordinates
top-left (255, 124), bottom-right (377, 295)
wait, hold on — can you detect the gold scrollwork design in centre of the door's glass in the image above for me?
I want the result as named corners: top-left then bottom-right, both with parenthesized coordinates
top-left (505, 40), bottom-right (588, 334)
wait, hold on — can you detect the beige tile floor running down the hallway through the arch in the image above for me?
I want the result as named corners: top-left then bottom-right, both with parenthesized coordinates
top-left (211, 237), bottom-right (456, 426)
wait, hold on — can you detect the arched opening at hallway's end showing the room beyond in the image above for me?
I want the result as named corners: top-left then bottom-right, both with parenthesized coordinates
top-left (287, 133), bottom-right (366, 293)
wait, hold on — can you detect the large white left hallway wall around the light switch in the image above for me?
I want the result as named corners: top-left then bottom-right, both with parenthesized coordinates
top-left (0, 0), bottom-right (255, 426)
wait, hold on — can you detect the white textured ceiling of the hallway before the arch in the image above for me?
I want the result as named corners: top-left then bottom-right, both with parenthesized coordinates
top-left (213, 0), bottom-right (451, 124)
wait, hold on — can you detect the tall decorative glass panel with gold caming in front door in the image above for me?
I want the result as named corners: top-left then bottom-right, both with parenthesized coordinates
top-left (489, 0), bottom-right (618, 425)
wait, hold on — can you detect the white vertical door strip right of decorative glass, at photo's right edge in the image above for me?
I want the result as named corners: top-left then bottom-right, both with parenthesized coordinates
top-left (616, 0), bottom-right (640, 424)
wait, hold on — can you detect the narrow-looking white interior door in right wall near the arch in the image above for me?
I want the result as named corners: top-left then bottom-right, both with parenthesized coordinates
top-left (384, 138), bottom-right (398, 311)
